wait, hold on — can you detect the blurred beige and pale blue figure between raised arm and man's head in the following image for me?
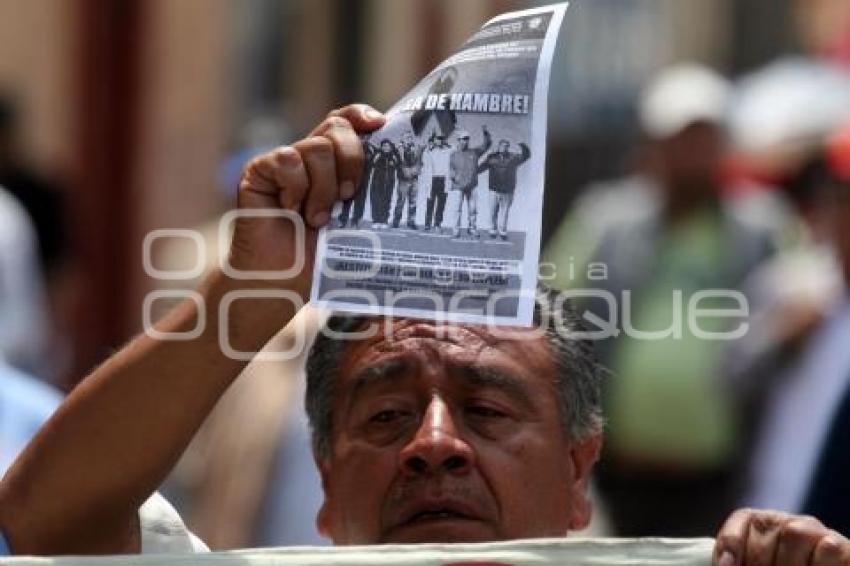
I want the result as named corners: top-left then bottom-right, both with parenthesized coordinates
top-left (163, 308), bottom-right (329, 549)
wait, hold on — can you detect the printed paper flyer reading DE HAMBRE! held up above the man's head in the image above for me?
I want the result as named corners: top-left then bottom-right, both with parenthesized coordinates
top-left (311, 3), bottom-right (567, 326)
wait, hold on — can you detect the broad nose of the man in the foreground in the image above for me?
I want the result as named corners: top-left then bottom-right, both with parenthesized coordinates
top-left (399, 397), bottom-right (475, 476)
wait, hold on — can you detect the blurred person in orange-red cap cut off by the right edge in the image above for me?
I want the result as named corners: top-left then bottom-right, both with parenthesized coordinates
top-left (745, 130), bottom-right (850, 532)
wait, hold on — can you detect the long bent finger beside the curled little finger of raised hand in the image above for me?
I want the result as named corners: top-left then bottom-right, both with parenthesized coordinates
top-left (295, 136), bottom-right (339, 228)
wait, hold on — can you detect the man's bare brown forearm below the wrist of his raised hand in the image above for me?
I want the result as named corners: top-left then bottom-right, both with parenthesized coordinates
top-left (0, 273), bottom-right (297, 554)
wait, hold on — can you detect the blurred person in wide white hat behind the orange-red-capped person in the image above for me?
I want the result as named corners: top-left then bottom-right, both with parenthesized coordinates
top-left (725, 57), bottom-right (850, 474)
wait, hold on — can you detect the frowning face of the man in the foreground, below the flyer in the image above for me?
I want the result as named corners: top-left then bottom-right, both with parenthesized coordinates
top-left (318, 319), bottom-right (601, 544)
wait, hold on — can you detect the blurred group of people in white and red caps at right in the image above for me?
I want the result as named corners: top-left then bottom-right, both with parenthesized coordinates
top-left (544, 58), bottom-right (850, 536)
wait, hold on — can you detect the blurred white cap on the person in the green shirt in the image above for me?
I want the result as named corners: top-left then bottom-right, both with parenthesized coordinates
top-left (640, 63), bottom-right (731, 139)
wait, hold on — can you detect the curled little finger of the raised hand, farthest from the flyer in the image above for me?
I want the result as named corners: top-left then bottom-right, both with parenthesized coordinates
top-left (239, 147), bottom-right (307, 212)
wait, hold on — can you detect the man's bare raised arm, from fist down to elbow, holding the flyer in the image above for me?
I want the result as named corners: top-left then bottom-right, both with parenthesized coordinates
top-left (0, 105), bottom-right (383, 554)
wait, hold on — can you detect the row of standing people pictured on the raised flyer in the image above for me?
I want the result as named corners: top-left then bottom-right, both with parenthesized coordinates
top-left (337, 125), bottom-right (531, 240)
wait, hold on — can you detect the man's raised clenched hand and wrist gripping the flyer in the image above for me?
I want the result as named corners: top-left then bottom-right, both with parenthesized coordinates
top-left (230, 104), bottom-right (384, 299)
